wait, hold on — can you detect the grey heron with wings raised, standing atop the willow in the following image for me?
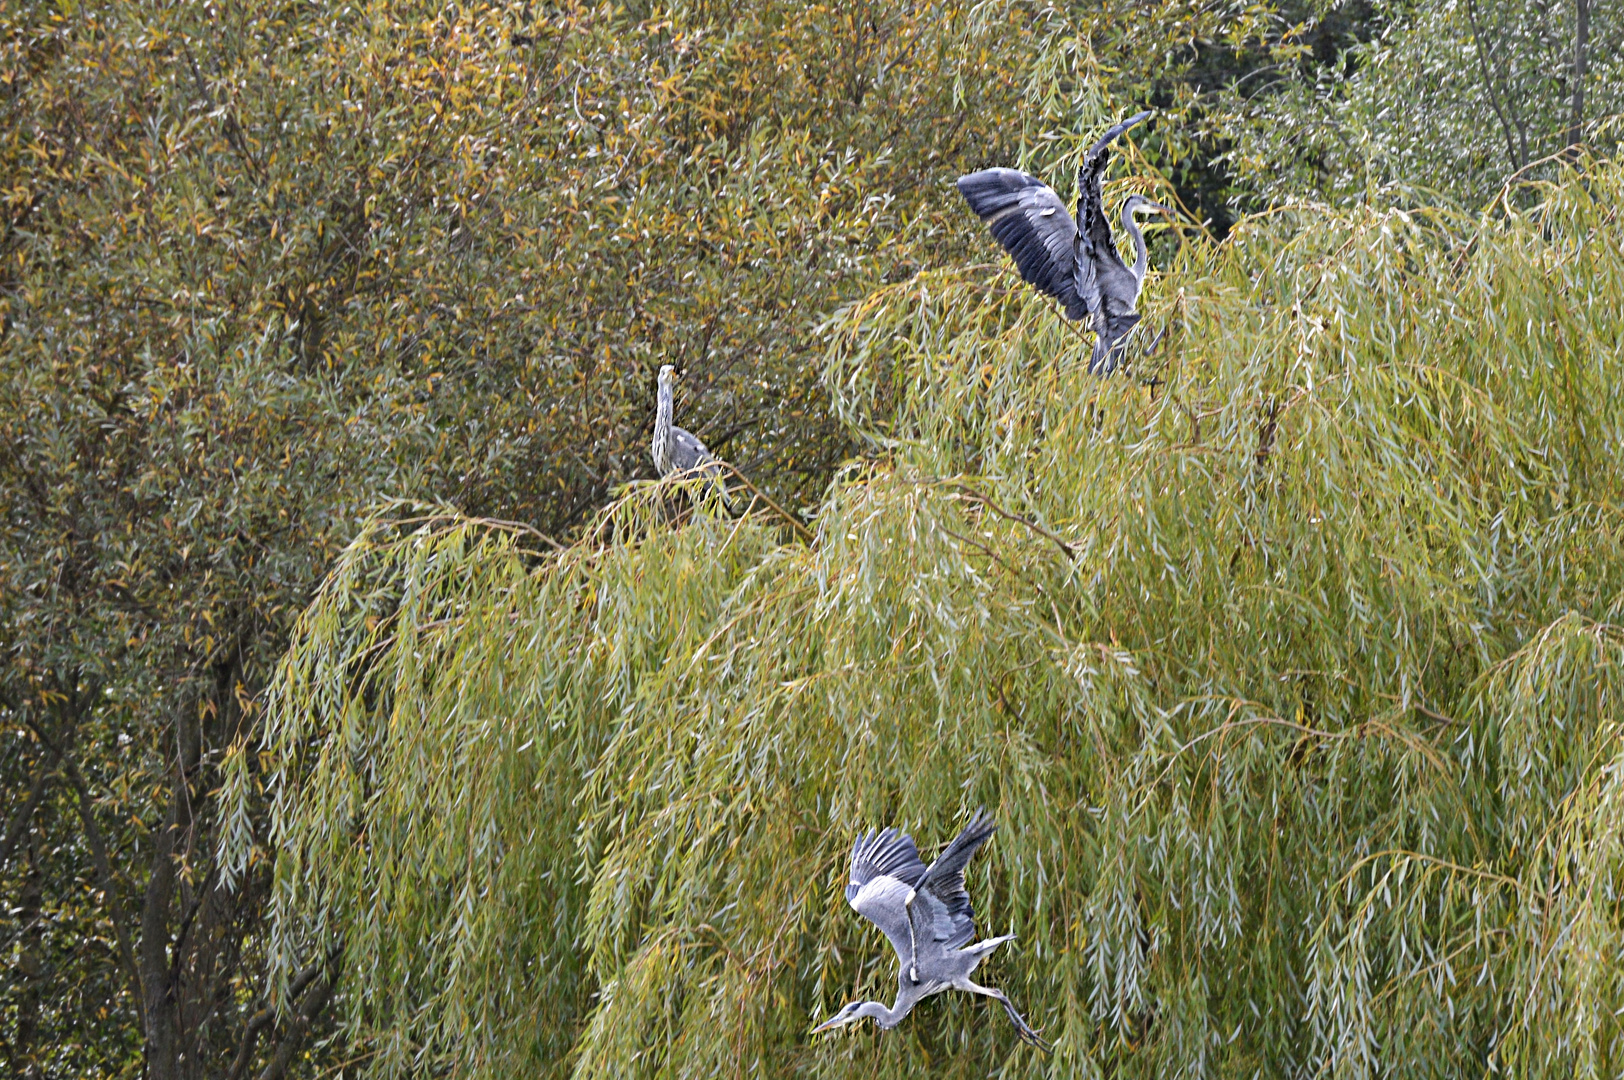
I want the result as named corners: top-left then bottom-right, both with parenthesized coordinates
top-left (958, 112), bottom-right (1173, 375)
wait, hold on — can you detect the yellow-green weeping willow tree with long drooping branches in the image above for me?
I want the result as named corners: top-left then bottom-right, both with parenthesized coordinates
top-left (227, 155), bottom-right (1624, 1077)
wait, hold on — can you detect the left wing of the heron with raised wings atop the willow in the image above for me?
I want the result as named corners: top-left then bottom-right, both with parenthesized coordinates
top-left (958, 169), bottom-right (1091, 318)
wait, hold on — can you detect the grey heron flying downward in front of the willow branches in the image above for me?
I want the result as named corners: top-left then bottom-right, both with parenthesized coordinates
top-left (812, 810), bottom-right (1049, 1051)
